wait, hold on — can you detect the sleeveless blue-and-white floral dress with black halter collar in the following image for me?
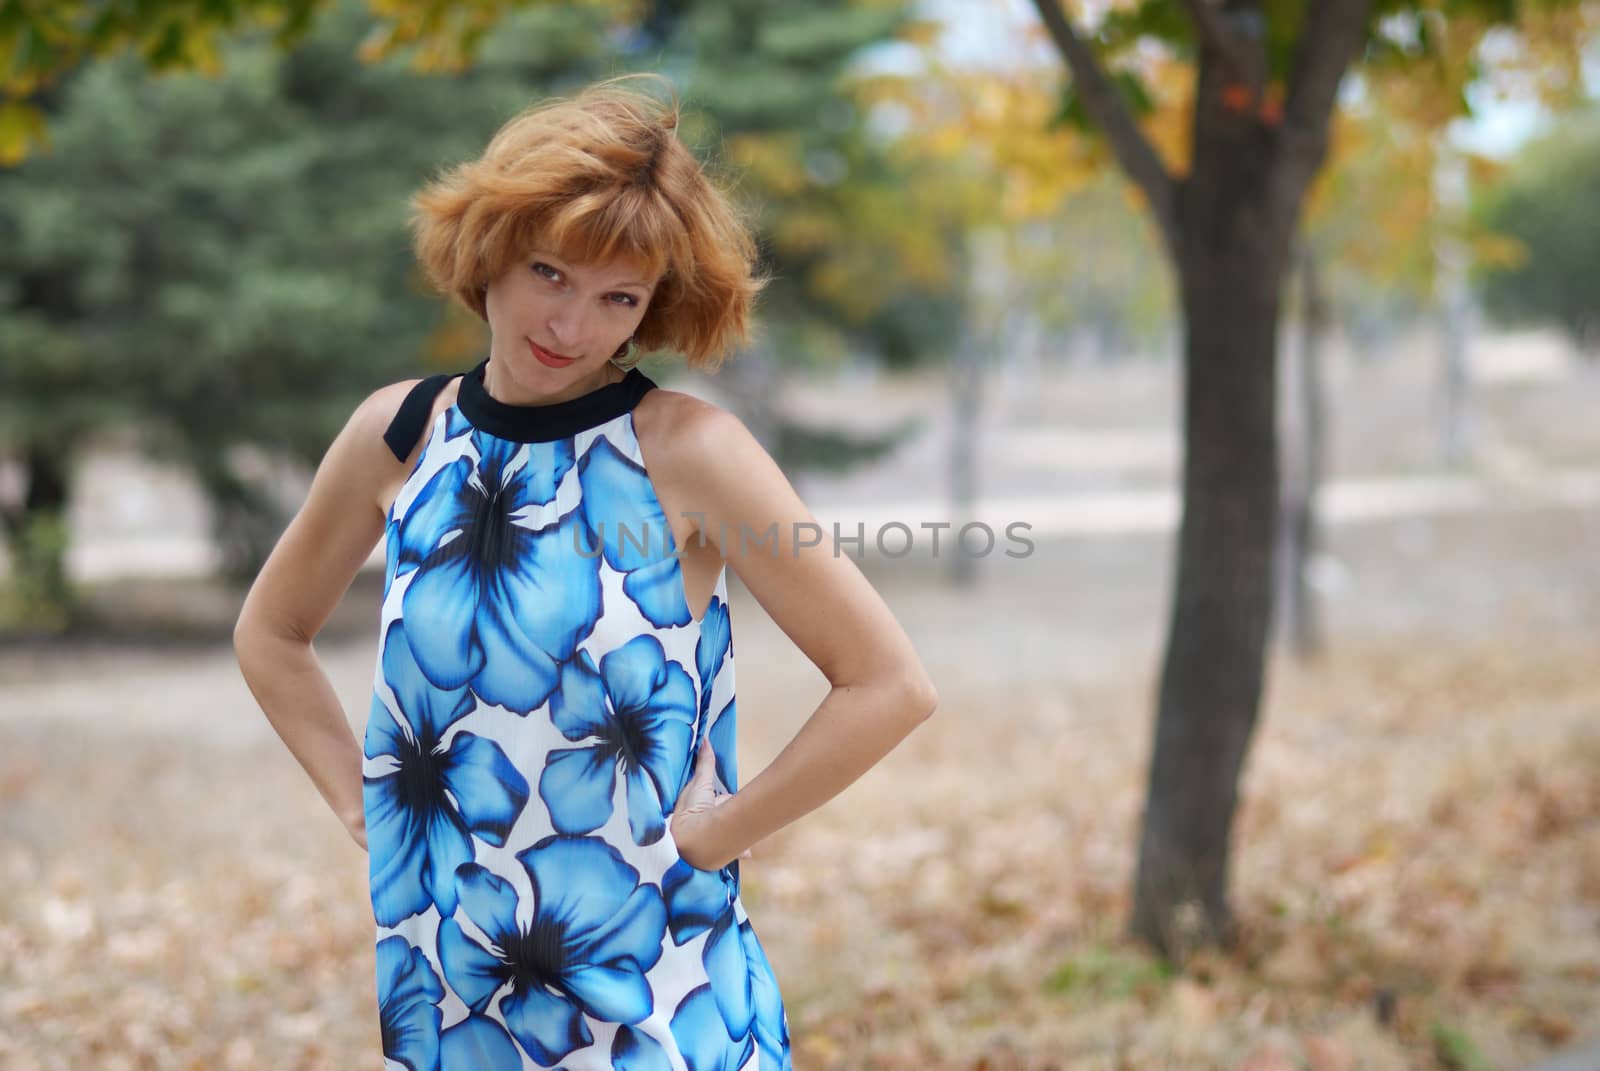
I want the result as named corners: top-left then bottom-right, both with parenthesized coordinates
top-left (363, 360), bottom-right (790, 1071)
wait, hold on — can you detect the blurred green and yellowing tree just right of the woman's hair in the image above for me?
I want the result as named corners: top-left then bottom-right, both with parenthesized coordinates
top-left (630, 0), bottom-right (965, 467)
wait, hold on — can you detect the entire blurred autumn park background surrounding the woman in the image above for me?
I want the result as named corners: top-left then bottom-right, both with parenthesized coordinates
top-left (0, 0), bottom-right (1600, 1071)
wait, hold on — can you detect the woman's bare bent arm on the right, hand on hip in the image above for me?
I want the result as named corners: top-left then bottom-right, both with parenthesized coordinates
top-left (664, 405), bottom-right (938, 869)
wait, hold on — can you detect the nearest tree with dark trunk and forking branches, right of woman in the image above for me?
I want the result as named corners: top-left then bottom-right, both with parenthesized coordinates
top-left (1034, 0), bottom-right (1593, 957)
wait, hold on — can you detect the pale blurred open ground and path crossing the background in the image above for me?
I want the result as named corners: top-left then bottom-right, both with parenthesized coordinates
top-left (15, 326), bottom-right (1600, 581)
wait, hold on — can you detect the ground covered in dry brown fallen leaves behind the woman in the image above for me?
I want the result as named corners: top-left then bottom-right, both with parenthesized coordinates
top-left (0, 608), bottom-right (1600, 1071)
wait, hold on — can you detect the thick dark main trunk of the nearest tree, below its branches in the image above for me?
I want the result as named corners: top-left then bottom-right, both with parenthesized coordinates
top-left (1130, 100), bottom-right (1298, 962)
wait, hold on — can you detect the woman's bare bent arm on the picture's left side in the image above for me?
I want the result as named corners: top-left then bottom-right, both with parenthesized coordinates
top-left (234, 383), bottom-right (411, 847)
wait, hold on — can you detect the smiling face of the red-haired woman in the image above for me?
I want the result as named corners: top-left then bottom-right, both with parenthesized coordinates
top-left (485, 250), bottom-right (656, 402)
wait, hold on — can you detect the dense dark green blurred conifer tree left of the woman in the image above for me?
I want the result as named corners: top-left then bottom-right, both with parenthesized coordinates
top-left (0, 4), bottom-right (534, 608)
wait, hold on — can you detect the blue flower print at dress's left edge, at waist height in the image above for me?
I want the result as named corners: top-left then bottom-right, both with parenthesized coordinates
top-left (362, 621), bottom-right (528, 925)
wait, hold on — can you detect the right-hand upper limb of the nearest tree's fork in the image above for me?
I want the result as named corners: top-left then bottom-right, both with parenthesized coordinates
top-left (1282, 0), bottom-right (1373, 203)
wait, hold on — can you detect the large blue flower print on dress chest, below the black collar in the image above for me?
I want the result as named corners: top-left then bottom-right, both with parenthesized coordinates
top-left (400, 432), bottom-right (600, 714)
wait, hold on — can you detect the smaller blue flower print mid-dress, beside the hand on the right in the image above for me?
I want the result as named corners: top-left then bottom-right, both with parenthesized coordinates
top-left (539, 634), bottom-right (694, 844)
